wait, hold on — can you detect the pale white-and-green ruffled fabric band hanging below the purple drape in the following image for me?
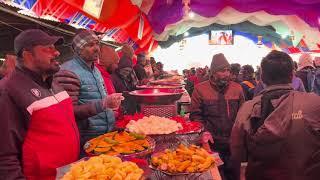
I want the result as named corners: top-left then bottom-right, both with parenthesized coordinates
top-left (155, 7), bottom-right (320, 48)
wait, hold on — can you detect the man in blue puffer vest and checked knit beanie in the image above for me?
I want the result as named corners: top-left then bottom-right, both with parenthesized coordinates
top-left (55, 30), bottom-right (123, 156)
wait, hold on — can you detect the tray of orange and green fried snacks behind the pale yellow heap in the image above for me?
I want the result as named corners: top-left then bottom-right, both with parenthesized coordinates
top-left (84, 131), bottom-right (155, 157)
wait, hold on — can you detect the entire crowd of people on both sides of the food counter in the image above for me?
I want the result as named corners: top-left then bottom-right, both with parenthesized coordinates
top-left (0, 29), bottom-right (320, 180)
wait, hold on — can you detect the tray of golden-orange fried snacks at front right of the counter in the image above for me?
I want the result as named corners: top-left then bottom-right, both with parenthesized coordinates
top-left (150, 144), bottom-right (216, 176)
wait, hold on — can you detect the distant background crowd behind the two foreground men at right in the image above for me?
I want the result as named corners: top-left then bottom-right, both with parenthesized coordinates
top-left (183, 53), bottom-right (320, 101)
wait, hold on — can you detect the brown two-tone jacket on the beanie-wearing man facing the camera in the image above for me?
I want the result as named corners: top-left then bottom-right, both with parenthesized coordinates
top-left (190, 80), bottom-right (244, 145)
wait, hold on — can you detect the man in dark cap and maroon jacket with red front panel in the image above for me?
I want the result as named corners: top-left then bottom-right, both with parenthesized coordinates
top-left (0, 29), bottom-right (79, 179)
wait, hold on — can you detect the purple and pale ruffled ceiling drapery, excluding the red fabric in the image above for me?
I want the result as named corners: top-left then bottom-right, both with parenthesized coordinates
top-left (131, 0), bottom-right (320, 48)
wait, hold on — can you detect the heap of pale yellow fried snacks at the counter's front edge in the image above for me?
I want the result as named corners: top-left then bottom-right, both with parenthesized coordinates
top-left (57, 155), bottom-right (144, 180)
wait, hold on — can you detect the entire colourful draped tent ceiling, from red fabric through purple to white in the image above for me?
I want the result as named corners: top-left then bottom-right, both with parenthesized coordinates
top-left (4, 0), bottom-right (320, 51)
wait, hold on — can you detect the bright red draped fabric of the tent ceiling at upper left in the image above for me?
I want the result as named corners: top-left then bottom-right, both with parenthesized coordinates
top-left (27, 0), bottom-right (158, 52)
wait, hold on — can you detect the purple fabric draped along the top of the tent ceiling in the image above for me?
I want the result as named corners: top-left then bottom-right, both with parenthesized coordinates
top-left (142, 0), bottom-right (320, 34)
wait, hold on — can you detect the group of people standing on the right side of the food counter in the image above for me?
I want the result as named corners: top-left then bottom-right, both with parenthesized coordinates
top-left (188, 51), bottom-right (320, 180)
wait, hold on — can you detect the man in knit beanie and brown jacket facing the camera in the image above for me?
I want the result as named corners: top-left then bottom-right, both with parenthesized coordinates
top-left (190, 53), bottom-right (244, 180)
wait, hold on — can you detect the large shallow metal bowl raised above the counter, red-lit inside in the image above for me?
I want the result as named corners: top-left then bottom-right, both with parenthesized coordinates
top-left (129, 89), bottom-right (184, 104)
